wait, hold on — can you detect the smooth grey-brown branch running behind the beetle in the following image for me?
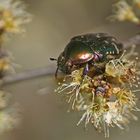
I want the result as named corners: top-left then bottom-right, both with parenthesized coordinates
top-left (1, 35), bottom-right (140, 85)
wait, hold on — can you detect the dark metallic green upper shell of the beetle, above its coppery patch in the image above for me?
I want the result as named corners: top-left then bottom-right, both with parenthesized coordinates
top-left (64, 33), bottom-right (123, 63)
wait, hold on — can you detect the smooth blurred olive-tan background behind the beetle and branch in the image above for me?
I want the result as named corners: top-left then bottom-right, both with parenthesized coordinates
top-left (0, 0), bottom-right (140, 140)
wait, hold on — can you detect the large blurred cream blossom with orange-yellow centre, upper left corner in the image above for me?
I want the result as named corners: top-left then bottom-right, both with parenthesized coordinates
top-left (0, 0), bottom-right (31, 33)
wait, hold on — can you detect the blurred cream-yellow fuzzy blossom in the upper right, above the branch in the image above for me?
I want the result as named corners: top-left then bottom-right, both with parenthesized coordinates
top-left (110, 0), bottom-right (140, 24)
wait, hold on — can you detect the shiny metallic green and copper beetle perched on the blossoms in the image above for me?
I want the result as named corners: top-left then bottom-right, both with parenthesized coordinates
top-left (50, 33), bottom-right (123, 77)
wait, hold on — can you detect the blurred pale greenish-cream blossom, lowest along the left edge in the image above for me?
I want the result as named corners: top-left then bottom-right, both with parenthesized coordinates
top-left (0, 90), bottom-right (21, 134)
